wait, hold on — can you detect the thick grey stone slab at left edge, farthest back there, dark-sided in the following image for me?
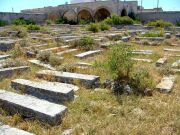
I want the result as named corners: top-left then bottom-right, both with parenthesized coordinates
top-left (0, 40), bottom-right (15, 51)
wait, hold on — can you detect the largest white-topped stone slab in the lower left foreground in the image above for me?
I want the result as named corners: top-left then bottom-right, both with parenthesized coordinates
top-left (0, 90), bottom-right (67, 124)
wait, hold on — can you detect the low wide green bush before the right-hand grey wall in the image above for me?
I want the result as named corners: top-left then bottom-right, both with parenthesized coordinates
top-left (147, 20), bottom-right (173, 28)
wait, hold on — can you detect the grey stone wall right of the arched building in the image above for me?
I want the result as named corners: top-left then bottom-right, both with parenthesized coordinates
top-left (137, 11), bottom-right (180, 24)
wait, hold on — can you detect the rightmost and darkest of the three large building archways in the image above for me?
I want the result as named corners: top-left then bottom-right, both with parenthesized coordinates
top-left (94, 8), bottom-right (111, 21)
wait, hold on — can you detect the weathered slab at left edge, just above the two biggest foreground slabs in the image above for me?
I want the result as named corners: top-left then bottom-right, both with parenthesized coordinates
top-left (0, 66), bottom-right (30, 79)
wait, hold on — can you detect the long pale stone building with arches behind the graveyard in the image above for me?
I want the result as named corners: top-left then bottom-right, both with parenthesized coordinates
top-left (21, 0), bottom-right (138, 21)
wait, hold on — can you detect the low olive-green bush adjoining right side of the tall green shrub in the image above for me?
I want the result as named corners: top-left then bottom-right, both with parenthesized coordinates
top-left (130, 69), bottom-right (154, 93)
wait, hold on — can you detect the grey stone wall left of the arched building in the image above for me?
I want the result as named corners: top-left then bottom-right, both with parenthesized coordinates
top-left (0, 12), bottom-right (47, 24)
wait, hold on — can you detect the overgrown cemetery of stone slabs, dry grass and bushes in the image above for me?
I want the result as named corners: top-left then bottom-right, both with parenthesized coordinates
top-left (0, 1), bottom-right (180, 135)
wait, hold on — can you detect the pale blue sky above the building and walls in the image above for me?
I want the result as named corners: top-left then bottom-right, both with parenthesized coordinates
top-left (0, 0), bottom-right (180, 12)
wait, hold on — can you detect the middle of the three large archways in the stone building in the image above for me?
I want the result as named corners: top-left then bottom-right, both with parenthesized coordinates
top-left (77, 9), bottom-right (93, 22)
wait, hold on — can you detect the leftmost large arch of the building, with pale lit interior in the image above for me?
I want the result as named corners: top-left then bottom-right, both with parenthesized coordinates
top-left (62, 10), bottom-right (77, 22)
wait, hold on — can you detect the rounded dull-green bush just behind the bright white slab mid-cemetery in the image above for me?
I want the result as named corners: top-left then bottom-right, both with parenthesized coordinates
top-left (73, 37), bottom-right (94, 51)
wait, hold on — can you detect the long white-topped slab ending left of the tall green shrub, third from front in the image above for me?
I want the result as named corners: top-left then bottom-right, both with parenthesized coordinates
top-left (37, 70), bottom-right (100, 88)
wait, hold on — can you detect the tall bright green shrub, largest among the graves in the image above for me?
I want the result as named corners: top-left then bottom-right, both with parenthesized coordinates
top-left (106, 44), bottom-right (134, 81)
